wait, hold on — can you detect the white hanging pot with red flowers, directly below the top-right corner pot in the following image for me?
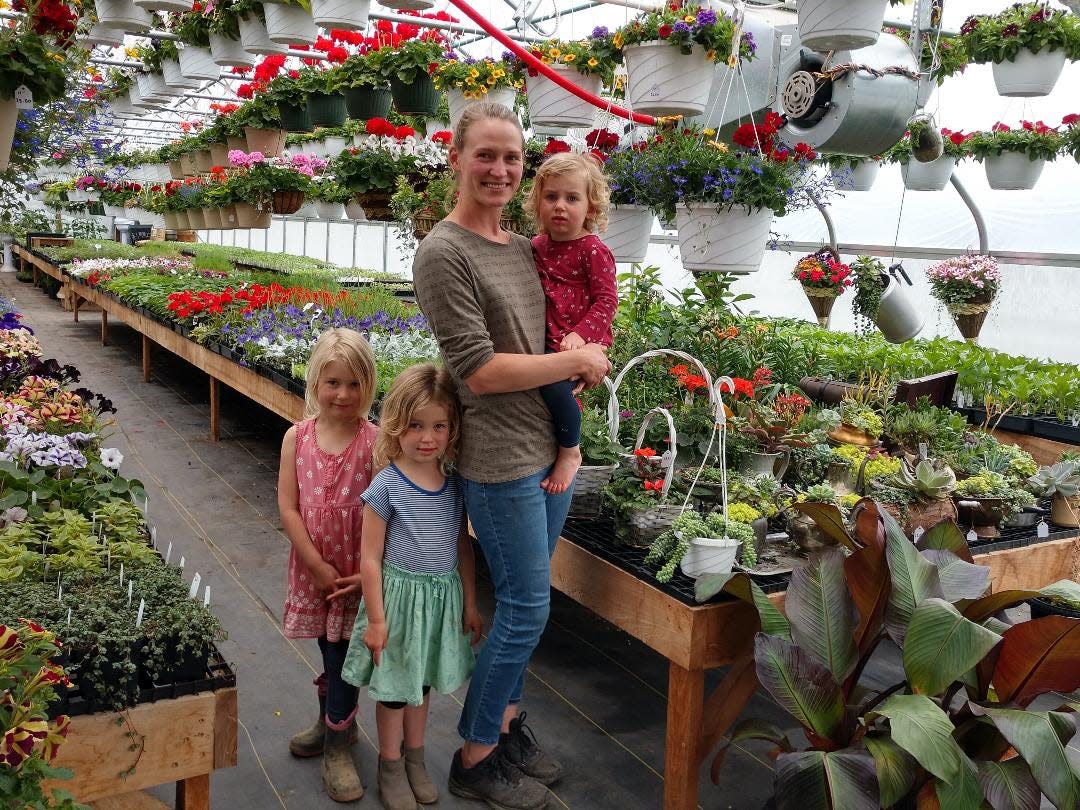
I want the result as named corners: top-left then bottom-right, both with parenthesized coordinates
top-left (971, 121), bottom-right (1062, 190)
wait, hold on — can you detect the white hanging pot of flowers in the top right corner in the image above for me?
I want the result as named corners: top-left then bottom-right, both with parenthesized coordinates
top-left (960, 2), bottom-right (1080, 98)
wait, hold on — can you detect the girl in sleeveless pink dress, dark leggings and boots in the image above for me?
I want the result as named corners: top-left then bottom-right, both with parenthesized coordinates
top-left (278, 329), bottom-right (377, 801)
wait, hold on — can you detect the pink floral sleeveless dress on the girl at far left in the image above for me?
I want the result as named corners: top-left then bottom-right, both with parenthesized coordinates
top-left (284, 419), bottom-right (378, 642)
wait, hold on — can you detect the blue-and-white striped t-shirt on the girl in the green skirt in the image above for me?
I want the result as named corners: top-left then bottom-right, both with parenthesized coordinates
top-left (361, 464), bottom-right (464, 573)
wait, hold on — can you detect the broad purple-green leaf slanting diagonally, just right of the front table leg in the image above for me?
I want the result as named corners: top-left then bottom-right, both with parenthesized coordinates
top-left (754, 633), bottom-right (848, 744)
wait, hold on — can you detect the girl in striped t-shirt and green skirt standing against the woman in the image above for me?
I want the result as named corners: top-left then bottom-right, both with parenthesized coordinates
top-left (334, 363), bottom-right (483, 810)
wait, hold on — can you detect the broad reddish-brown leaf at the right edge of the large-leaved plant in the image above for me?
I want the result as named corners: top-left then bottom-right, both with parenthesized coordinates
top-left (993, 616), bottom-right (1080, 706)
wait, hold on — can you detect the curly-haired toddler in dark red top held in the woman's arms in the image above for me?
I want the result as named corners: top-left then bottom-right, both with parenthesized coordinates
top-left (525, 152), bottom-right (619, 494)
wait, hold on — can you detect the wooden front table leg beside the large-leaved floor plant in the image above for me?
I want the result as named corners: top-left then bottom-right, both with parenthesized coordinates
top-left (664, 661), bottom-right (705, 810)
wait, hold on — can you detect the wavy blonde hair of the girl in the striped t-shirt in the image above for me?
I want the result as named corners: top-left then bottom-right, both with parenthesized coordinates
top-left (373, 363), bottom-right (461, 473)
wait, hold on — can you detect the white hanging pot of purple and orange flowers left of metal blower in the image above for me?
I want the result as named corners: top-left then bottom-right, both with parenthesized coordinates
top-left (611, 3), bottom-right (757, 116)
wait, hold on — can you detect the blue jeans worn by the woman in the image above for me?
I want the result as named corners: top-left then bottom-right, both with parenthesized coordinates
top-left (458, 470), bottom-right (573, 745)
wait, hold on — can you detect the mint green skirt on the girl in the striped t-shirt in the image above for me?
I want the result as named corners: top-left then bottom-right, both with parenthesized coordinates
top-left (341, 563), bottom-right (475, 706)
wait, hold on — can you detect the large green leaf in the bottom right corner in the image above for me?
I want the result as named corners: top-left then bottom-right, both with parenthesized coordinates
top-left (968, 702), bottom-right (1080, 810)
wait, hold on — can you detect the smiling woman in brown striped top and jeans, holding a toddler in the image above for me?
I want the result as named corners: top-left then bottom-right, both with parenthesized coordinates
top-left (413, 103), bottom-right (611, 810)
